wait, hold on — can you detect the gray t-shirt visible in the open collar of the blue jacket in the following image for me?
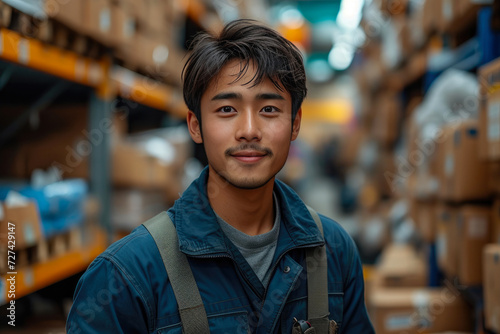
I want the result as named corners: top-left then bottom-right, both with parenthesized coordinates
top-left (215, 193), bottom-right (281, 285)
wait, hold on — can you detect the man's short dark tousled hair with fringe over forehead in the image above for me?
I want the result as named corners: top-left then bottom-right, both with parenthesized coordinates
top-left (182, 19), bottom-right (307, 124)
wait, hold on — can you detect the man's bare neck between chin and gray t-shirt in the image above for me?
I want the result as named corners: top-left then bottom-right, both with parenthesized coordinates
top-left (207, 167), bottom-right (275, 235)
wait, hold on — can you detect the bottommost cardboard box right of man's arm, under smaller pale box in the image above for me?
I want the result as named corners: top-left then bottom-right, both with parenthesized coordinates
top-left (368, 288), bottom-right (473, 334)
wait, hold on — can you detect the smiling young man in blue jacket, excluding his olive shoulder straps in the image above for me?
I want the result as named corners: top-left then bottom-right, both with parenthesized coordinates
top-left (67, 20), bottom-right (373, 334)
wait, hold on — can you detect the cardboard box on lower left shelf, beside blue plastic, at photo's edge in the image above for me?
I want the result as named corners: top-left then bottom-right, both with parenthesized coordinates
top-left (0, 202), bottom-right (43, 250)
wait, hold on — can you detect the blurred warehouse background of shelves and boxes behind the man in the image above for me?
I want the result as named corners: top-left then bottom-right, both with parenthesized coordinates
top-left (0, 0), bottom-right (500, 334)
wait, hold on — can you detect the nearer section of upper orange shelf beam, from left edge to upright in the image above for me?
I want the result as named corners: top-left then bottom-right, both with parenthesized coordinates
top-left (0, 28), bottom-right (107, 87)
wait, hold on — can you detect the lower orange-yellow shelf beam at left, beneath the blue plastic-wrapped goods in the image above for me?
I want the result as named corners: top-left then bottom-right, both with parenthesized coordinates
top-left (0, 228), bottom-right (108, 305)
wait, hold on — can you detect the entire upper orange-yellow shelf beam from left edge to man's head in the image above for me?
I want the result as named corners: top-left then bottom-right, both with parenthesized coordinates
top-left (0, 28), bottom-right (187, 118)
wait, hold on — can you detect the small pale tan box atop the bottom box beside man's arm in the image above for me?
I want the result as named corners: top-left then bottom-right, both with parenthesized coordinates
top-left (377, 244), bottom-right (427, 288)
